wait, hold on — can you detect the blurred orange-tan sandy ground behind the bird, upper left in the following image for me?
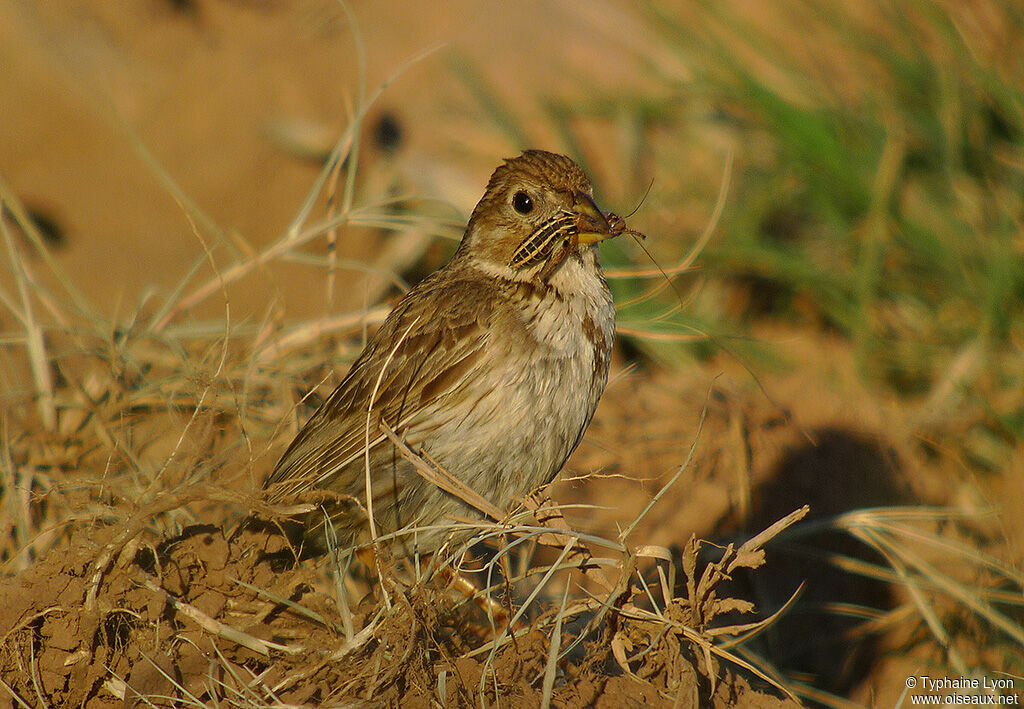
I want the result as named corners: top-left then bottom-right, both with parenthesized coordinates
top-left (0, 0), bottom-right (688, 316)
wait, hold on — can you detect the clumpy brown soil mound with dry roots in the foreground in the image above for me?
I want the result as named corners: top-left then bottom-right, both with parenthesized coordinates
top-left (0, 518), bottom-right (796, 707)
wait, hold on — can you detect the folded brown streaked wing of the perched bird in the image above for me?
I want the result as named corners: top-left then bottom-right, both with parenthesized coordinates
top-left (264, 270), bottom-right (497, 499)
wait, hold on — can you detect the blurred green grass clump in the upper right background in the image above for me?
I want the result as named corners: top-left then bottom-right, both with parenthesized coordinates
top-left (649, 0), bottom-right (1024, 466)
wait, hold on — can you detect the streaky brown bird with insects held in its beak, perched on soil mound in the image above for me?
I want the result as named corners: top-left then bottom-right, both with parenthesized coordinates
top-left (264, 150), bottom-right (632, 557)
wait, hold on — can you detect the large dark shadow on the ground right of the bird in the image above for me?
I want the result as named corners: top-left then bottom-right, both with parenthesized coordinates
top-left (744, 428), bottom-right (910, 696)
